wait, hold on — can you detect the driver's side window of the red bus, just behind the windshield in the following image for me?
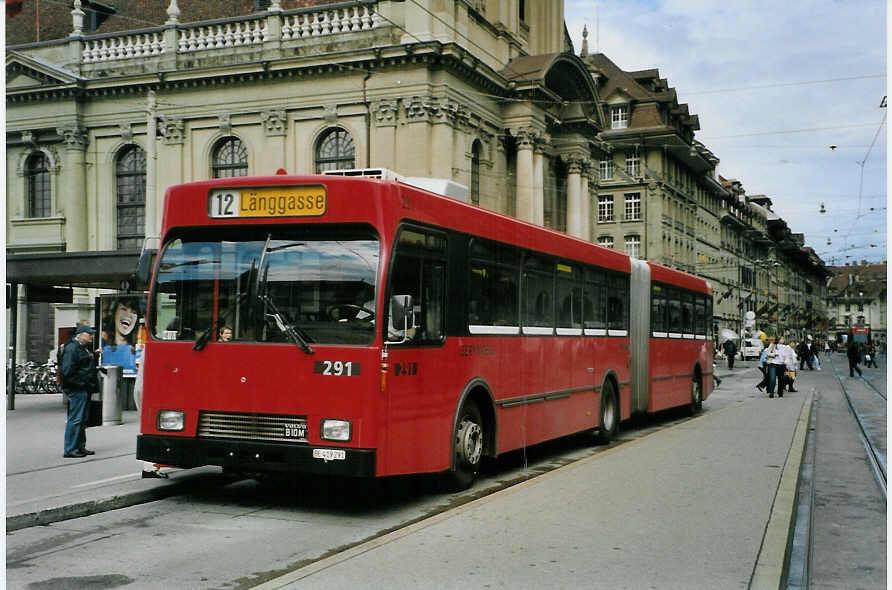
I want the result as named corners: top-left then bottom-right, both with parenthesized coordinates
top-left (384, 229), bottom-right (446, 344)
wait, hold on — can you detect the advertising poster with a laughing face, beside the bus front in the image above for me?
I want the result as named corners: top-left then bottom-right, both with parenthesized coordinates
top-left (96, 293), bottom-right (146, 377)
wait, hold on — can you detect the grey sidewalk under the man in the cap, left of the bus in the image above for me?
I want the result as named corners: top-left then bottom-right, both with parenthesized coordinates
top-left (6, 394), bottom-right (222, 531)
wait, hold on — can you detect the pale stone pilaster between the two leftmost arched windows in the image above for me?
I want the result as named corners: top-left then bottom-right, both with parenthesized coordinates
top-left (56, 123), bottom-right (89, 252)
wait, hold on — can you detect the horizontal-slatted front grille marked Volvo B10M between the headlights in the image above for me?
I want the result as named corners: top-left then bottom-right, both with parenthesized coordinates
top-left (198, 412), bottom-right (307, 442)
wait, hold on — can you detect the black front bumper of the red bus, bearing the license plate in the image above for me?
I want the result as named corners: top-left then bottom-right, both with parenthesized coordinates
top-left (136, 434), bottom-right (375, 477)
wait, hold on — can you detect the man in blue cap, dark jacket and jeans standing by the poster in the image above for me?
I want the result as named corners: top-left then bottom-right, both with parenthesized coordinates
top-left (62, 326), bottom-right (99, 459)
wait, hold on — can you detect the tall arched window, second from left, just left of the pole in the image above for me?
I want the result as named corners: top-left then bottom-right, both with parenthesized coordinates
top-left (115, 145), bottom-right (146, 250)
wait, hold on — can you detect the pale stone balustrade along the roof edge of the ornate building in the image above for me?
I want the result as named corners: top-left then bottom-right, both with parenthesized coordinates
top-left (81, 2), bottom-right (385, 64)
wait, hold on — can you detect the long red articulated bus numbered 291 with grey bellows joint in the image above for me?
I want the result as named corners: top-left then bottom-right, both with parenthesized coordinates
top-left (137, 173), bottom-right (713, 488)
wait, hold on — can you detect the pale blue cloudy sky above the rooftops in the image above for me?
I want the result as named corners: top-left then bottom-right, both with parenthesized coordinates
top-left (564, 0), bottom-right (888, 265)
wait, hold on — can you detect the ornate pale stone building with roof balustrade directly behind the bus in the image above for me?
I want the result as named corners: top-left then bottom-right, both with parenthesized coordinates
top-left (6, 0), bottom-right (604, 359)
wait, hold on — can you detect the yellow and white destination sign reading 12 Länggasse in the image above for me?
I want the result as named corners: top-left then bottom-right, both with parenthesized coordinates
top-left (208, 185), bottom-right (328, 218)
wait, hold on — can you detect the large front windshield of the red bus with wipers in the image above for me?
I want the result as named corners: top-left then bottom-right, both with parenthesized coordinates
top-left (150, 226), bottom-right (380, 345)
